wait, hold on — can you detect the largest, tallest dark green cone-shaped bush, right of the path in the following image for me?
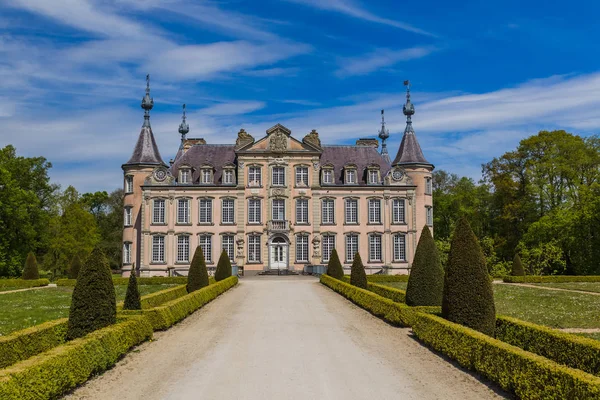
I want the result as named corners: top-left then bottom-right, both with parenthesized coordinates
top-left (442, 217), bottom-right (496, 336)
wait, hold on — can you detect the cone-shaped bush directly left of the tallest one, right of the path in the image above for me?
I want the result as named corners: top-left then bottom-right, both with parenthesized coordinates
top-left (406, 226), bottom-right (444, 306)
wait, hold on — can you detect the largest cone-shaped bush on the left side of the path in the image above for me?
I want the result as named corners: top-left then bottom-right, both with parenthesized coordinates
top-left (67, 247), bottom-right (117, 340)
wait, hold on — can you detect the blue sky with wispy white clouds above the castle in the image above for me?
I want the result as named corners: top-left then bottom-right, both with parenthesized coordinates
top-left (0, 0), bottom-right (600, 191)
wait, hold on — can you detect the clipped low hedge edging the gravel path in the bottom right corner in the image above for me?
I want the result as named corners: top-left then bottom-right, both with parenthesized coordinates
top-left (413, 313), bottom-right (600, 399)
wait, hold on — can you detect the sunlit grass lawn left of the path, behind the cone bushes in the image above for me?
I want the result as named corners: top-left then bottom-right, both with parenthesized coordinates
top-left (0, 285), bottom-right (176, 336)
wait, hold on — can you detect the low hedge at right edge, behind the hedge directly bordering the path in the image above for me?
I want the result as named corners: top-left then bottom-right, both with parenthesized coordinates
top-left (496, 316), bottom-right (600, 376)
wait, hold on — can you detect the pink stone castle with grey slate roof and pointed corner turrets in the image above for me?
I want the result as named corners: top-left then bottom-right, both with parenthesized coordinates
top-left (122, 78), bottom-right (434, 276)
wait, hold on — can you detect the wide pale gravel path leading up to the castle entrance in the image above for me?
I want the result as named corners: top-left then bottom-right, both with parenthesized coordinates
top-left (67, 277), bottom-right (502, 400)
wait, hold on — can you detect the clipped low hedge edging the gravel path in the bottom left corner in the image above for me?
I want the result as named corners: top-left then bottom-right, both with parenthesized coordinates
top-left (0, 317), bottom-right (152, 400)
